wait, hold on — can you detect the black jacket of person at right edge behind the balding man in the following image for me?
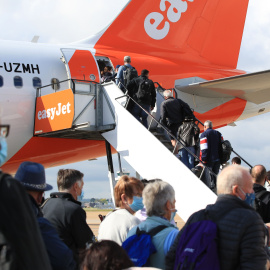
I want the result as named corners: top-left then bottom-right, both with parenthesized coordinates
top-left (253, 184), bottom-right (270, 223)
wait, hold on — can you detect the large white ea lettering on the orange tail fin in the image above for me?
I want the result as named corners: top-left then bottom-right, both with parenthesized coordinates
top-left (144, 0), bottom-right (193, 40)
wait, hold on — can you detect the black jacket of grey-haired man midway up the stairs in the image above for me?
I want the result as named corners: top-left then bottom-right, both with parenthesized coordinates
top-left (160, 97), bottom-right (183, 127)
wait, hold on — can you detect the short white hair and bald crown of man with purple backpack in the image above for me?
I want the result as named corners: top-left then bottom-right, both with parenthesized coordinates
top-left (217, 165), bottom-right (251, 195)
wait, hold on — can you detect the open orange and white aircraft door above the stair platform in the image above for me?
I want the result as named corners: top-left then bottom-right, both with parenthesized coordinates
top-left (61, 49), bottom-right (100, 82)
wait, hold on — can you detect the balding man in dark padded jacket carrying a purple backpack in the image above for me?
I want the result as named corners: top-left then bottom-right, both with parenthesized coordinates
top-left (166, 165), bottom-right (266, 270)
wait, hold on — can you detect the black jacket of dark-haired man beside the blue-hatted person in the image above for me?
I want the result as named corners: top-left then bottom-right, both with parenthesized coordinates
top-left (42, 192), bottom-right (94, 258)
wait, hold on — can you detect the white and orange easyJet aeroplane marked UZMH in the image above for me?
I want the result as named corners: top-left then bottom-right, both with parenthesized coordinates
top-left (0, 0), bottom-right (270, 173)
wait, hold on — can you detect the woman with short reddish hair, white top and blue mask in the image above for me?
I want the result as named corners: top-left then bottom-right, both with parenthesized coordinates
top-left (98, 175), bottom-right (144, 245)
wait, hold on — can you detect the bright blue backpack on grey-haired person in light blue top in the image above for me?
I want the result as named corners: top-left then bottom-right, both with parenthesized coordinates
top-left (122, 225), bottom-right (168, 267)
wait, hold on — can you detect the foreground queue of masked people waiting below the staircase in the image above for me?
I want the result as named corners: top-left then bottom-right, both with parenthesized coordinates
top-left (0, 120), bottom-right (270, 270)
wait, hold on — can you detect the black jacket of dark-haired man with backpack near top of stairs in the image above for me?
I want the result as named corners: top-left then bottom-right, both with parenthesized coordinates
top-left (127, 76), bottom-right (156, 108)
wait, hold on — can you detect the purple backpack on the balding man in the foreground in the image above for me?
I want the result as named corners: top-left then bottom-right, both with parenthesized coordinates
top-left (174, 210), bottom-right (220, 270)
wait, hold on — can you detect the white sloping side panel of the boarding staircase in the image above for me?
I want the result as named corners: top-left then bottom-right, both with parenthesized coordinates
top-left (99, 82), bottom-right (216, 221)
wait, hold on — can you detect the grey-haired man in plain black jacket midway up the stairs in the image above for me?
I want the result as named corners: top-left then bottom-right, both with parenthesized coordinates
top-left (160, 90), bottom-right (184, 150)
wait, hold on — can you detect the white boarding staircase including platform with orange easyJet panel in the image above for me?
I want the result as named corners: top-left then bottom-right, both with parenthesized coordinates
top-left (34, 79), bottom-right (249, 221)
